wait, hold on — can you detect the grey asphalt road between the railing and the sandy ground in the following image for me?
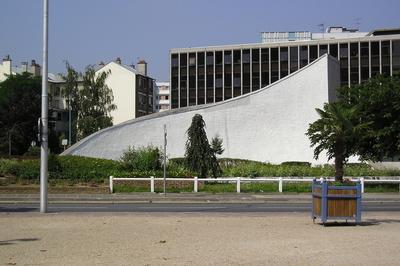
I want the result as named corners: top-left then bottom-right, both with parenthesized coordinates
top-left (0, 202), bottom-right (400, 213)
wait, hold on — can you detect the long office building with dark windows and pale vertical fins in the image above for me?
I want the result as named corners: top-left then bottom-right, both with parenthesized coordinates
top-left (170, 27), bottom-right (400, 109)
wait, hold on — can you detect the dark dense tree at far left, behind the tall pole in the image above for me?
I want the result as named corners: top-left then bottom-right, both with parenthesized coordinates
top-left (0, 73), bottom-right (42, 155)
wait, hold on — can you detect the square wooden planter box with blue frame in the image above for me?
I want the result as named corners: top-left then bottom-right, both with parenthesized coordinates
top-left (311, 180), bottom-right (361, 224)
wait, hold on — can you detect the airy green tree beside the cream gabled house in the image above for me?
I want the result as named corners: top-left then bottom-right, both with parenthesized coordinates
top-left (74, 66), bottom-right (117, 140)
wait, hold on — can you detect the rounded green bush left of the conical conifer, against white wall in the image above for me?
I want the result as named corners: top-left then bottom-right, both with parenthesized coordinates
top-left (121, 146), bottom-right (161, 171)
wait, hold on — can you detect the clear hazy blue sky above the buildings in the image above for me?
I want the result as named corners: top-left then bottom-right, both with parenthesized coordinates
top-left (0, 0), bottom-right (400, 81)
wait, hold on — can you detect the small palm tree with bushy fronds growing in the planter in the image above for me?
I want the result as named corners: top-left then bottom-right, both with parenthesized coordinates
top-left (306, 102), bottom-right (364, 182)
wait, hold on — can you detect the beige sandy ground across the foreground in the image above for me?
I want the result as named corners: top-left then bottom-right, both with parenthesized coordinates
top-left (0, 213), bottom-right (400, 265)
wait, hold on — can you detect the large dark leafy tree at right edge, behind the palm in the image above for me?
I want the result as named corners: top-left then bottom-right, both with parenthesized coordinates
top-left (339, 72), bottom-right (400, 161)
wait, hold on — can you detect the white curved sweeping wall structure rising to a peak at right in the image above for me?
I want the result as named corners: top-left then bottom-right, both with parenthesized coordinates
top-left (63, 55), bottom-right (340, 163)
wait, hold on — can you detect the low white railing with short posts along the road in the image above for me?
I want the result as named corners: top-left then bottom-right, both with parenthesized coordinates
top-left (110, 176), bottom-right (400, 193)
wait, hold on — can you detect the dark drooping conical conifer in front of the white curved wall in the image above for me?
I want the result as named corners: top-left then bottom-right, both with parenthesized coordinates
top-left (185, 114), bottom-right (221, 178)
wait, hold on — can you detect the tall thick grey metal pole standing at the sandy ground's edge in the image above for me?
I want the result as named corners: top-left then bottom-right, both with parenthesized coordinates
top-left (40, 0), bottom-right (49, 213)
